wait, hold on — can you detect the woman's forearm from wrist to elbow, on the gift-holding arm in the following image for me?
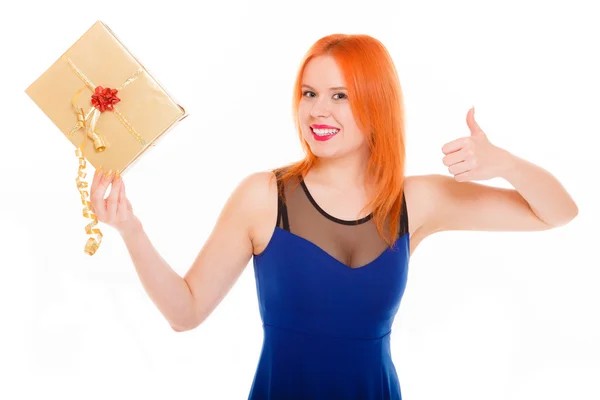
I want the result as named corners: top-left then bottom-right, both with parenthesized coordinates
top-left (121, 220), bottom-right (196, 331)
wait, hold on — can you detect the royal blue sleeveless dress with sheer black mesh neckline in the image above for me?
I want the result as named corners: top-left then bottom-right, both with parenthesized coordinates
top-left (248, 170), bottom-right (410, 400)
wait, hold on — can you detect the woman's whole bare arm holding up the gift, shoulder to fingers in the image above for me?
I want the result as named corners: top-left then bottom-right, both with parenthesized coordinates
top-left (92, 171), bottom-right (276, 332)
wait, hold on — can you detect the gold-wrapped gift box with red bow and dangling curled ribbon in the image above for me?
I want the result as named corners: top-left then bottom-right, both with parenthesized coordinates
top-left (25, 21), bottom-right (187, 255)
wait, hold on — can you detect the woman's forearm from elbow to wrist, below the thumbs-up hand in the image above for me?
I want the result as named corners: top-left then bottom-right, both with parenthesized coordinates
top-left (501, 152), bottom-right (578, 226)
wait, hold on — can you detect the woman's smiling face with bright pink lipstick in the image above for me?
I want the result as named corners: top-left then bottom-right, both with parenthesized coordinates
top-left (298, 56), bottom-right (367, 158)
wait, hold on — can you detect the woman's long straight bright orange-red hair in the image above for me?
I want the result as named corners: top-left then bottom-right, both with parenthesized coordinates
top-left (280, 34), bottom-right (406, 246)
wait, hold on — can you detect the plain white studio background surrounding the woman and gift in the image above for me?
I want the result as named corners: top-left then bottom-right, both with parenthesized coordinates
top-left (0, 0), bottom-right (600, 400)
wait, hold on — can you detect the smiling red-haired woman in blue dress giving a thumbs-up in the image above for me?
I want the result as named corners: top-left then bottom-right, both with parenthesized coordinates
top-left (91, 35), bottom-right (578, 399)
